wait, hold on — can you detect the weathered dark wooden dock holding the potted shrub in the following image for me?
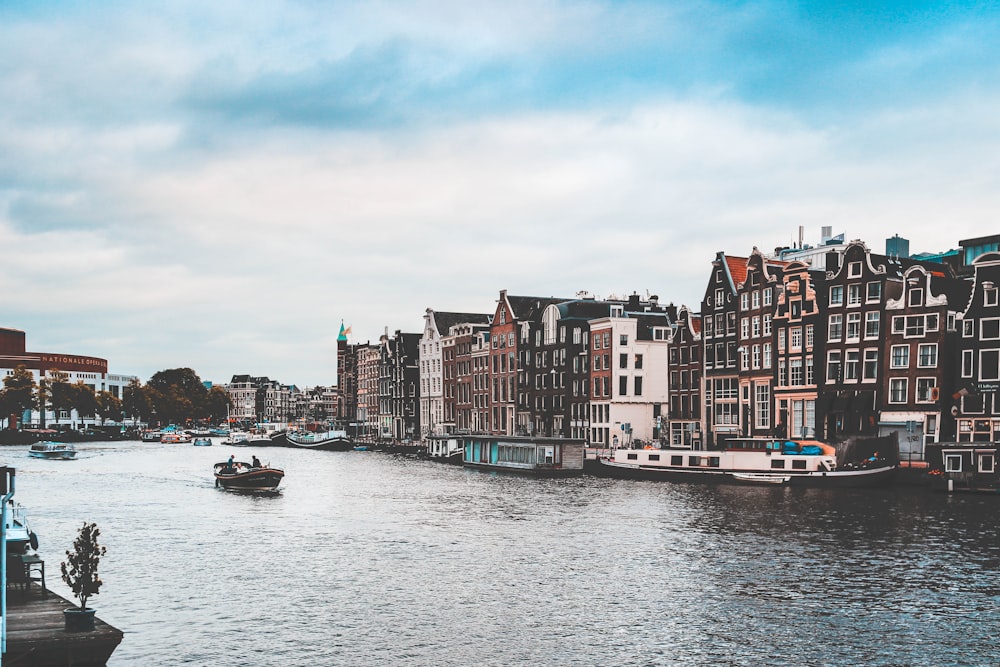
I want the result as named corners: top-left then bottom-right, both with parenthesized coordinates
top-left (3, 582), bottom-right (123, 667)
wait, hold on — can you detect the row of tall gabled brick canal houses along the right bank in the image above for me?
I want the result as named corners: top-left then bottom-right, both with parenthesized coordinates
top-left (338, 236), bottom-right (1000, 470)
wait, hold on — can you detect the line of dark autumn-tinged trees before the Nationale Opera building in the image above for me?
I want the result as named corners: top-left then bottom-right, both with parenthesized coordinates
top-left (0, 365), bottom-right (230, 428)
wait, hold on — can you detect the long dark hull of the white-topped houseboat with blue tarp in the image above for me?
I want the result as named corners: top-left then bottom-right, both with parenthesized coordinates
top-left (587, 459), bottom-right (898, 488)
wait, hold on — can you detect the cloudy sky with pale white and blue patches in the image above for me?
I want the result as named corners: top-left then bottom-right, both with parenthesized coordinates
top-left (0, 0), bottom-right (1000, 386)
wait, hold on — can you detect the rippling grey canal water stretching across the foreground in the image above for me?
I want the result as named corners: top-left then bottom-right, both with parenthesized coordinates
top-left (7, 442), bottom-right (1000, 666)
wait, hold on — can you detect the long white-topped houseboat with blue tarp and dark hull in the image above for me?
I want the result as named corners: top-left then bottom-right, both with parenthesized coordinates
top-left (588, 438), bottom-right (899, 487)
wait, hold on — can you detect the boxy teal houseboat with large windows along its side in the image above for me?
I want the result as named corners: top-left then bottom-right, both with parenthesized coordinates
top-left (455, 435), bottom-right (584, 477)
